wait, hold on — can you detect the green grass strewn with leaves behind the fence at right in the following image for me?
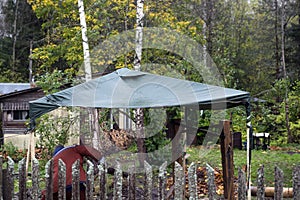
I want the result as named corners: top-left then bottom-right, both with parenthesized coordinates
top-left (187, 146), bottom-right (300, 187)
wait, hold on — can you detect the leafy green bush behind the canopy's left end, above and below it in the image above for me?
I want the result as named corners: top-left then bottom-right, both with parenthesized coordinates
top-left (35, 69), bottom-right (78, 157)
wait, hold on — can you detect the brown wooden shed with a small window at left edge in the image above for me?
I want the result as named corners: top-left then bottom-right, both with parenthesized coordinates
top-left (0, 87), bottom-right (45, 145)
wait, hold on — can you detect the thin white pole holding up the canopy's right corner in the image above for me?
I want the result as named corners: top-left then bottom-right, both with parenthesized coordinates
top-left (246, 102), bottom-right (252, 200)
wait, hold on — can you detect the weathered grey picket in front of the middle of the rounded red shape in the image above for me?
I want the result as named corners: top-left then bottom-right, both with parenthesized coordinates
top-left (72, 159), bottom-right (80, 200)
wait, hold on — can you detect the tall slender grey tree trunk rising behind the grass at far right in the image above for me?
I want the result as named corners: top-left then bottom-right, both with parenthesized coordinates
top-left (281, 0), bottom-right (293, 143)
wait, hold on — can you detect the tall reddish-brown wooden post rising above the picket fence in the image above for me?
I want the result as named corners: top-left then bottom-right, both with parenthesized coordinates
top-left (220, 120), bottom-right (234, 199)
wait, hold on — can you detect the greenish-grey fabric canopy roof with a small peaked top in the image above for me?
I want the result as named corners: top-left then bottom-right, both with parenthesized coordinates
top-left (29, 68), bottom-right (250, 121)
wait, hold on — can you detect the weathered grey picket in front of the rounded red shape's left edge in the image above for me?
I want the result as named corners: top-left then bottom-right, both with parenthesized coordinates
top-left (58, 159), bottom-right (66, 200)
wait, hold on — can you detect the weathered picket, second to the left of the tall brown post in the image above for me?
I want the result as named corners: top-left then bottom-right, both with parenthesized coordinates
top-left (188, 162), bottom-right (198, 200)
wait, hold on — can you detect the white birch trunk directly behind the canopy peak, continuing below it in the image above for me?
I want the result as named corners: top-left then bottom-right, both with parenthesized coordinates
top-left (133, 0), bottom-right (146, 167)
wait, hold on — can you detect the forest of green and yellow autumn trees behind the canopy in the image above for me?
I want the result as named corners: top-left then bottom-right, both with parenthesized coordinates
top-left (0, 0), bottom-right (300, 148)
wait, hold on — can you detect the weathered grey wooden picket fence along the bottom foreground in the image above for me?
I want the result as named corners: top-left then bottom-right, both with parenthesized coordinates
top-left (0, 156), bottom-right (300, 200)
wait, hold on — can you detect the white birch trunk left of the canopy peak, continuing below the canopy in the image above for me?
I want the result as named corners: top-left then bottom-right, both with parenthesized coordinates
top-left (78, 0), bottom-right (99, 150)
